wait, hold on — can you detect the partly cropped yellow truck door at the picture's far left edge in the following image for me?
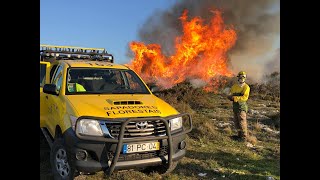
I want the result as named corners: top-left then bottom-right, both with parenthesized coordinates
top-left (40, 61), bottom-right (50, 127)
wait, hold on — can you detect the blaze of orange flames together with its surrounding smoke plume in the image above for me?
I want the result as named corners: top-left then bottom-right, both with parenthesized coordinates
top-left (128, 0), bottom-right (280, 92)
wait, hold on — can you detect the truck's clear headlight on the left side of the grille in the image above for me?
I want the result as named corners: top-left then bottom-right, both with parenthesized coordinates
top-left (77, 119), bottom-right (103, 136)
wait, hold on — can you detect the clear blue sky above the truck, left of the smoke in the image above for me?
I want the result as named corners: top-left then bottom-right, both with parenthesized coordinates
top-left (40, 0), bottom-right (176, 64)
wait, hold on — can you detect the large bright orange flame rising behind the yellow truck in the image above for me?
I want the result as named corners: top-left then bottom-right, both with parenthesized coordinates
top-left (129, 10), bottom-right (237, 91)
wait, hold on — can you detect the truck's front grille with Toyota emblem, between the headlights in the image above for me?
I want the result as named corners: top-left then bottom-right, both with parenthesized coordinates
top-left (105, 120), bottom-right (166, 138)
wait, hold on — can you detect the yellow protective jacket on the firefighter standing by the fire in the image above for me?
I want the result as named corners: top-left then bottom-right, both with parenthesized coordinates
top-left (230, 83), bottom-right (250, 112)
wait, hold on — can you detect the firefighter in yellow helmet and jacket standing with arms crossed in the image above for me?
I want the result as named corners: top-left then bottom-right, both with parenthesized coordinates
top-left (228, 71), bottom-right (250, 141)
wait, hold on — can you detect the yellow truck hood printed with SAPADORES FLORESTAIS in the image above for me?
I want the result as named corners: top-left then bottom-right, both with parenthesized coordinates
top-left (67, 94), bottom-right (178, 118)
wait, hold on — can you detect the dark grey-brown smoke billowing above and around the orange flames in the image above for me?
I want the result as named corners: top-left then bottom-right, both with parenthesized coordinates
top-left (130, 0), bottom-right (280, 81)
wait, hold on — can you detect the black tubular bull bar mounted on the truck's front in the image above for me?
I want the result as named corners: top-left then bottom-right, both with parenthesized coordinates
top-left (75, 113), bottom-right (192, 175)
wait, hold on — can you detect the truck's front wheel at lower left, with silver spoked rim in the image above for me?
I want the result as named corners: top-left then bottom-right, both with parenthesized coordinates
top-left (50, 138), bottom-right (75, 180)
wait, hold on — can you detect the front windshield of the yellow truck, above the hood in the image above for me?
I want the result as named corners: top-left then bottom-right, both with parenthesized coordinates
top-left (66, 68), bottom-right (150, 95)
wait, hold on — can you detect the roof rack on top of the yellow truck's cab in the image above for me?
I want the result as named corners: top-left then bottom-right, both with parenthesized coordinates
top-left (40, 44), bottom-right (114, 63)
